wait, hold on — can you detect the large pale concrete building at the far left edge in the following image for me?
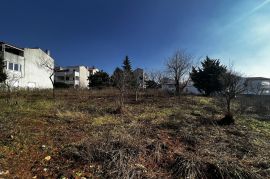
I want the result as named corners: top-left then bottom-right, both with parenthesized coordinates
top-left (0, 42), bottom-right (54, 89)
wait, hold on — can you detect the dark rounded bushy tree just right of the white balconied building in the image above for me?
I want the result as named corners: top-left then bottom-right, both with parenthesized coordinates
top-left (88, 71), bottom-right (110, 89)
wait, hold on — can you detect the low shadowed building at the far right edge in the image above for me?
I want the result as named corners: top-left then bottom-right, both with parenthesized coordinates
top-left (245, 77), bottom-right (270, 95)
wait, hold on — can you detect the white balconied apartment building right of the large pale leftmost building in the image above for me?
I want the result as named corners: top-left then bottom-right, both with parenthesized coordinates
top-left (54, 66), bottom-right (98, 88)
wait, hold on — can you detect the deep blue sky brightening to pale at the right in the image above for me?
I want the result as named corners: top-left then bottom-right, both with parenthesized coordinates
top-left (0, 0), bottom-right (270, 77)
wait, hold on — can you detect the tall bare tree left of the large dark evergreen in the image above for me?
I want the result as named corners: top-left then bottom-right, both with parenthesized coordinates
top-left (166, 50), bottom-right (193, 95)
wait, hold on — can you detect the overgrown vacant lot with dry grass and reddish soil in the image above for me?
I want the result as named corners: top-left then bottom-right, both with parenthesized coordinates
top-left (0, 91), bottom-right (270, 178)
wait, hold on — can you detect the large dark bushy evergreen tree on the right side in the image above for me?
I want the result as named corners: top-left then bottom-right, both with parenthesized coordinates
top-left (190, 56), bottom-right (227, 96)
